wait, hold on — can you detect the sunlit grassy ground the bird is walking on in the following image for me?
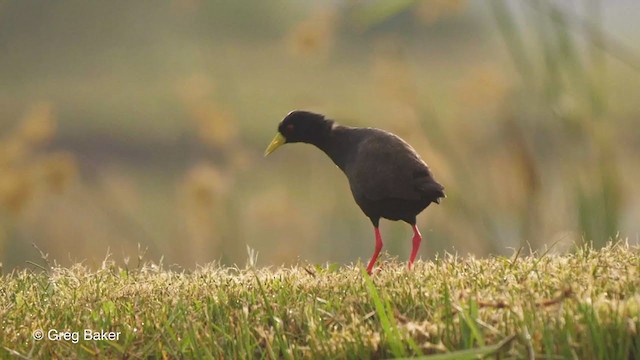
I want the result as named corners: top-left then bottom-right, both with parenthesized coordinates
top-left (0, 240), bottom-right (640, 359)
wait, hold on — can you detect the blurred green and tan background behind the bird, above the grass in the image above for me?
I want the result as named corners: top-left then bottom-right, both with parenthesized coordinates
top-left (0, 0), bottom-right (640, 271)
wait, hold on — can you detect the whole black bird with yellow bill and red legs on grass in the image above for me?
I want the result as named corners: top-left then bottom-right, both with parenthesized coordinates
top-left (264, 110), bottom-right (446, 275)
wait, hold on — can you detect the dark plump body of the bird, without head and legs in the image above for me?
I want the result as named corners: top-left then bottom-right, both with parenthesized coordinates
top-left (315, 123), bottom-right (444, 225)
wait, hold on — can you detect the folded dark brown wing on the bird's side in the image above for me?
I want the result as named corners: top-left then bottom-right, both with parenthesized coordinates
top-left (349, 132), bottom-right (442, 200)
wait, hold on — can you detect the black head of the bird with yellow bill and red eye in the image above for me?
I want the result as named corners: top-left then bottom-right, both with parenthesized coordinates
top-left (264, 110), bottom-right (333, 156)
